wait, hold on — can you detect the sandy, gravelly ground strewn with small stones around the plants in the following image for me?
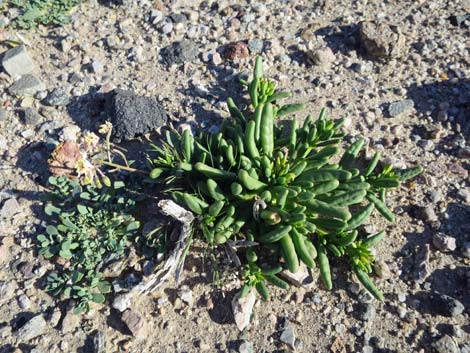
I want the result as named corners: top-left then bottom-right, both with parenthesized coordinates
top-left (0, 0), bottom-right (470, 353)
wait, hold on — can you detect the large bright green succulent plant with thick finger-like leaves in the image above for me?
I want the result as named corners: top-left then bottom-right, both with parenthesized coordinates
top-left (150, 57), bottom-right (422, 300)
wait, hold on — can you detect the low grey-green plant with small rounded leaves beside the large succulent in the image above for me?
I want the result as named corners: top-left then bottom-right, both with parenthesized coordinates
top-left (36, 176), bottom-right (139, 314)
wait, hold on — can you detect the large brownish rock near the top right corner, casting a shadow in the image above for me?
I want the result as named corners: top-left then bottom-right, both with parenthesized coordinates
top-left (359, 20), bottom-right (405, 58)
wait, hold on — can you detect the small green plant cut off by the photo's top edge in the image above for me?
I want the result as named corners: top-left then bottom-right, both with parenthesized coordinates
top-left (7, 0), bottom-right (83, 29)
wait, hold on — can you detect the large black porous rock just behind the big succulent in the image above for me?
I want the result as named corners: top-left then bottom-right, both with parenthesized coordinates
top-left (106, 89), bottom-right (168, 142)
